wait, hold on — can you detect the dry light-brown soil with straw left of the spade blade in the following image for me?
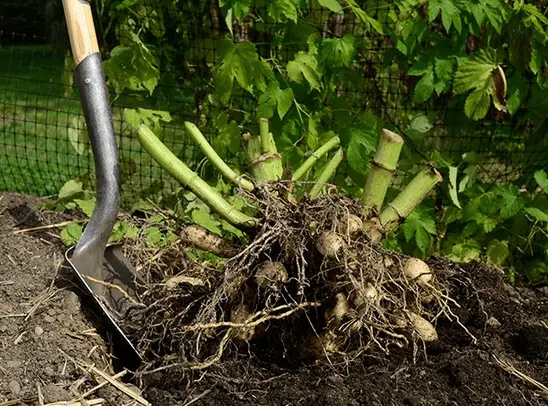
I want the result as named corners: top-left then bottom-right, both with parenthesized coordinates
top-left (0, 193), bottom-right (143, 405)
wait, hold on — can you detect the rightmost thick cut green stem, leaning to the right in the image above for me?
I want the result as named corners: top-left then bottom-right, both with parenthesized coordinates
top-left (380, 168), bottom-right (443, 232)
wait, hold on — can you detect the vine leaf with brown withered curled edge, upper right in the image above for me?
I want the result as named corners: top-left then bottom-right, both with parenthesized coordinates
top-left (453, 50), bottom-right (507, 120)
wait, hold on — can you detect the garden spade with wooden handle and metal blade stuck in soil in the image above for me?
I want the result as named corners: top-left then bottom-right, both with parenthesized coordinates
top-left (63, 0), bottom-right (144, 358)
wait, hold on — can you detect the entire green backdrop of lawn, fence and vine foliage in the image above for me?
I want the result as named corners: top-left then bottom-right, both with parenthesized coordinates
top-left (0, 0), bottom-right (548, 282)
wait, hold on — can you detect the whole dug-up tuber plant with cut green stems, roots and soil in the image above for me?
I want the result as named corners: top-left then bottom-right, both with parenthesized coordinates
top-left (115, 119), bottom-right (470, 372)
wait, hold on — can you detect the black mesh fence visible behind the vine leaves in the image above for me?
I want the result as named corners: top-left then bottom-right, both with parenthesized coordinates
top-left (0, 0), bottom-right (548, 203)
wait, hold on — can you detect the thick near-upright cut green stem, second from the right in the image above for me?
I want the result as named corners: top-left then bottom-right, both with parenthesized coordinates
top-left (362, 129), bottom-right (403, 217)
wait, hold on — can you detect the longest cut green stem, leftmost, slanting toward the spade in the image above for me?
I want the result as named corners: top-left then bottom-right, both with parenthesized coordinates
top-left (137, 124), bottom-right (258, 227)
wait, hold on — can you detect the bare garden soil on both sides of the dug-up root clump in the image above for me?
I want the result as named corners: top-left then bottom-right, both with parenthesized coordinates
top-left (0, 194), bottom-right (548, 406)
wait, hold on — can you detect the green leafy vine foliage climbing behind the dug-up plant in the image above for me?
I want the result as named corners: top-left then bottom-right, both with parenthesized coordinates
top-left (78, 0), bottom-right (548, 280)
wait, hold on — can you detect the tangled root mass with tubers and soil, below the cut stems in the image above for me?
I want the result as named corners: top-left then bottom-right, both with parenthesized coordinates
top-left (125, 187), bottom-right (470, 374)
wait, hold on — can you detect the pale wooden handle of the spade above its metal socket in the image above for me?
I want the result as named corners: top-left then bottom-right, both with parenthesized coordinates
top-left (63, 0), bottom-right (99, 66)
